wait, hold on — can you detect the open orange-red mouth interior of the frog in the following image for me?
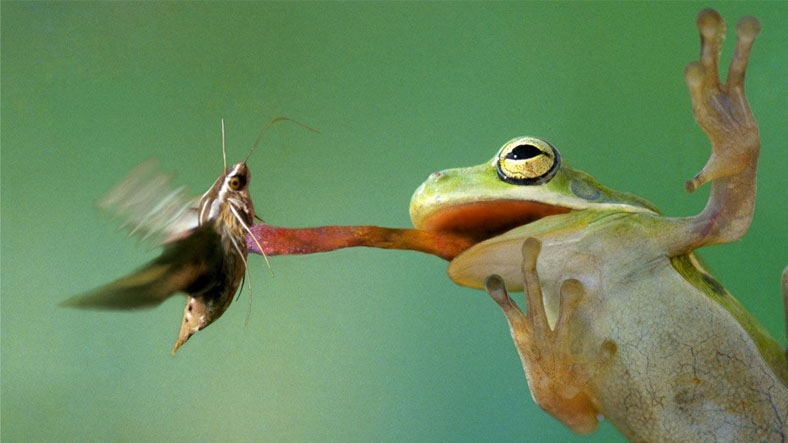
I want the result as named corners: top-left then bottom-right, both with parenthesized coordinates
top-left (416, 200), bottom-right (571, 246)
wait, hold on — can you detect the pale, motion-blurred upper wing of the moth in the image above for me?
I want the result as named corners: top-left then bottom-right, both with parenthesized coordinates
top-left (98, 159), bottom-right (197, 244)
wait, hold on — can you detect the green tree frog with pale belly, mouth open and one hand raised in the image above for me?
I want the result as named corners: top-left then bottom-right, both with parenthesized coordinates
top-left (409, 10), bottom-right (788, 441)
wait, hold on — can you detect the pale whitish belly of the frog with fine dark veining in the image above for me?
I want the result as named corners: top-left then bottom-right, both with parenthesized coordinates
top-left (568, 257), bottom-right (788, 441)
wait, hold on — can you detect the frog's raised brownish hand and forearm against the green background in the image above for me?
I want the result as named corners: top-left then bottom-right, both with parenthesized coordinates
top-left (664, 9), bottom-right (761, 255)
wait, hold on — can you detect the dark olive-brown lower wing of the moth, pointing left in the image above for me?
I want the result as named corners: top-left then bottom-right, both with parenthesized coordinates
top-left (60, 224), bottom-right (223, 309)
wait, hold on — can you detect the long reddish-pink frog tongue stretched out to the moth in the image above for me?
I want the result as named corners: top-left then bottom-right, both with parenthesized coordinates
top-left (246, 224), bottom-right (475, 260)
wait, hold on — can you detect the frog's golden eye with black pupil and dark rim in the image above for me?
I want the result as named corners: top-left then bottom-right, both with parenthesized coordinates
top-left (498, 137), bottom-right (561, 185)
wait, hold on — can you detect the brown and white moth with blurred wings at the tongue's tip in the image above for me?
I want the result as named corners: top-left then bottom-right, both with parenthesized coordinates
top-left (61, 117), bottom-right (302, 355)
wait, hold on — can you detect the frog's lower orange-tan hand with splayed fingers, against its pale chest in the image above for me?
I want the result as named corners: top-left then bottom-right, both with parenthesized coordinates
top-left (484, 238), bottom-right (616, 434)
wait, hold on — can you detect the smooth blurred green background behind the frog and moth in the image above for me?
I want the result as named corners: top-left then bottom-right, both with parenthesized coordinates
top-left (0, 2), bottom-right (788, 442)
